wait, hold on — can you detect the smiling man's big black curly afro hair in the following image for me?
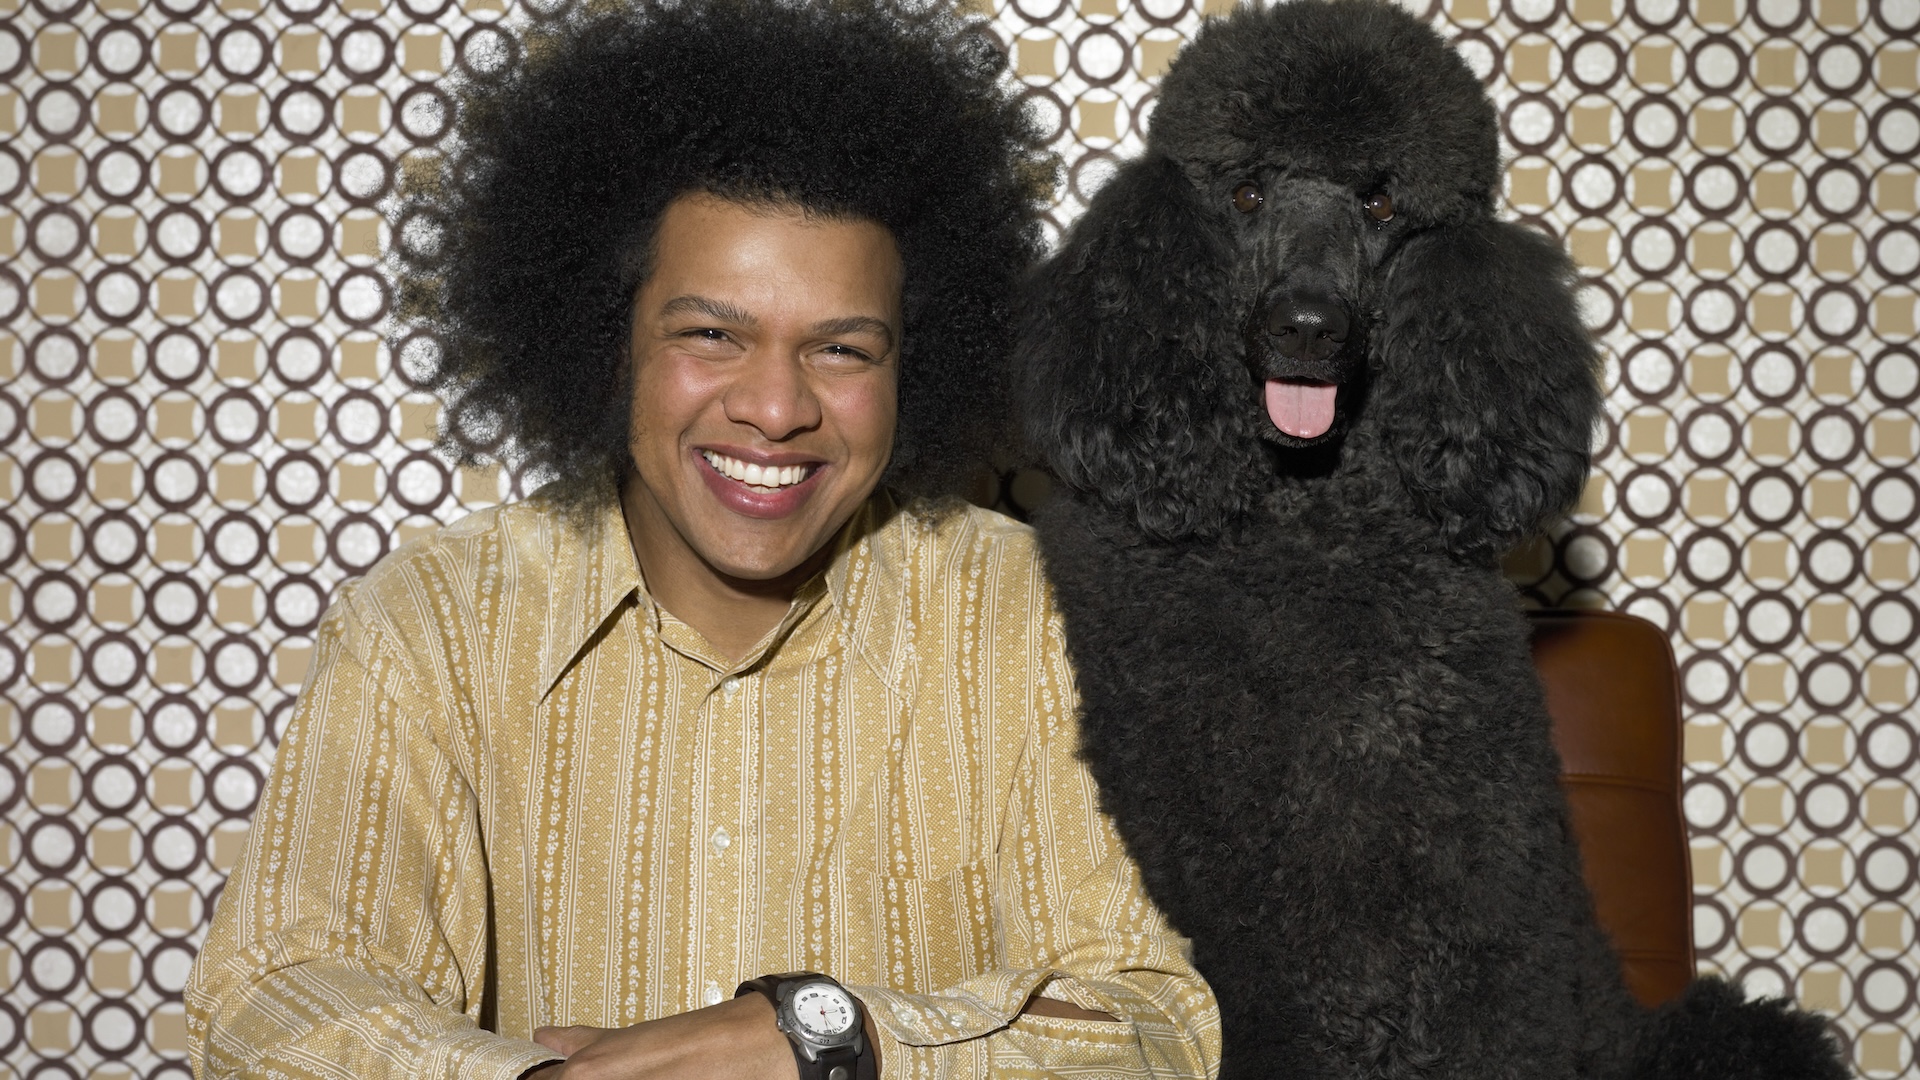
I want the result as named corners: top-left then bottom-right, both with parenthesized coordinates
top-left (396, 0), bottom-right (1052, 503)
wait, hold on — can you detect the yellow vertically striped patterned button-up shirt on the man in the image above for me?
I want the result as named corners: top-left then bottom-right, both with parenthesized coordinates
top-left (186, 496), bottom-right (1219, 1080)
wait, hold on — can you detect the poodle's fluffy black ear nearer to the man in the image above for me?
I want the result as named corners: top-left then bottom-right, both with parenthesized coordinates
top-left (1016, 154), bottom-right (1246, 538)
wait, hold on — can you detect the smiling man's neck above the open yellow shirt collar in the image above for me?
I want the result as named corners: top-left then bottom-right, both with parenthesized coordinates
top-left (620, 479), bottom-right (831, 661)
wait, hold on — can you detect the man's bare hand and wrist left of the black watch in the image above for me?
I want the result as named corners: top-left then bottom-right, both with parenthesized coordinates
top-left (528, 994), bottom-right (801, 1080)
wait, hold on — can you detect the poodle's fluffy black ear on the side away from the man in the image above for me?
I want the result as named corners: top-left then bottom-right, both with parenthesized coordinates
top-left (1375, 219), bottom-right (1601, 553)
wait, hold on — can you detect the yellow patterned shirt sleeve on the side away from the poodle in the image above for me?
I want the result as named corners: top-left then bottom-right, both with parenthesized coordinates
top-left (186, 586), bottom-right (557, 1080)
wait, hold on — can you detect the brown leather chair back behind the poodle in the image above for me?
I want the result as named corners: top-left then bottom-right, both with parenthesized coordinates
top-left (1528, 611), bottom-right (1693, 1005)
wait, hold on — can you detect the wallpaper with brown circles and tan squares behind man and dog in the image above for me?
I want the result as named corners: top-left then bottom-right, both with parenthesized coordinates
top-left (0, 0), bottom-right (1920, 1078)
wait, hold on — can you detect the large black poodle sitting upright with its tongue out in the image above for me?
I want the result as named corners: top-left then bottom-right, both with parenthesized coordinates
top-left (1020, 0), bottom-right (1845, 1080)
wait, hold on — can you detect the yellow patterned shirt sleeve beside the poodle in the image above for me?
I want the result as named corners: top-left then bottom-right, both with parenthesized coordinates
top-left (851, 580), bottom-right (1221, 1080)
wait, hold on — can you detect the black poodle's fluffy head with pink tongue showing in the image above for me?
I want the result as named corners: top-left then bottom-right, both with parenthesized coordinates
top-left (1021, 0), bottom-right (1599, 553)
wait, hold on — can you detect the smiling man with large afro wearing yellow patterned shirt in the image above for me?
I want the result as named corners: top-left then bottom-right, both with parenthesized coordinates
top-left (188, 0), bottom-right (1219, 1080)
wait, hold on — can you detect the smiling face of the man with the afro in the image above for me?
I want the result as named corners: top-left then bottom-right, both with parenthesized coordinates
top-left (628, 194), bottom-right (902, 580)
